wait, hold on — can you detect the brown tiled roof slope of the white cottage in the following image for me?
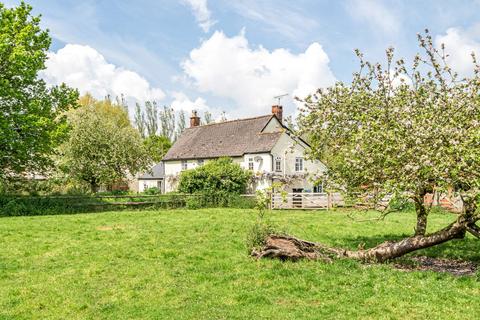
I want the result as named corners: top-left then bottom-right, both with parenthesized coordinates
top-left (163, 115), bottom-right (282, 160)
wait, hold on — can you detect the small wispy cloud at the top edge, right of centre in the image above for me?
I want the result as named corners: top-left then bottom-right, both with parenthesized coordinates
top-left (346, 0), bottom-right (400, 34)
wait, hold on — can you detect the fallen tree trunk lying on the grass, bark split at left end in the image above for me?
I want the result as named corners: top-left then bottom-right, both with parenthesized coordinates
top-left (252, 221), bottom-right (467, 262)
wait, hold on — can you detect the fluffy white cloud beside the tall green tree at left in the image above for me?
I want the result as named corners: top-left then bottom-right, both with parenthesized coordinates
top-left (41, 44), bottom-right (165, 101)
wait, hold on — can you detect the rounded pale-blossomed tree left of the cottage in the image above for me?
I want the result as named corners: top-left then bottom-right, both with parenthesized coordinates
top-left (61, 95), bottom-right (149, 192)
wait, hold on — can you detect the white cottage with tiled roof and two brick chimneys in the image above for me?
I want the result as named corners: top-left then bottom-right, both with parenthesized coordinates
top-left (163, 106), bottom-right (326, 192)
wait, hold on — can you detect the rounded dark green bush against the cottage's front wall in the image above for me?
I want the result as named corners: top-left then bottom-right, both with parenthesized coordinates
top-left (178, 158), bottom-right (251, 195)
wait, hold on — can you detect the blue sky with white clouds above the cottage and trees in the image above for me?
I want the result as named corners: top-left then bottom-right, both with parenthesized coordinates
top-left (4, 0), bottom-right (480, 119)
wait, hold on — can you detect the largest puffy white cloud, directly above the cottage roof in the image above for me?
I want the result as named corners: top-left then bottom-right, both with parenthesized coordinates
top-left (183, 31), bottom-right (335, 116)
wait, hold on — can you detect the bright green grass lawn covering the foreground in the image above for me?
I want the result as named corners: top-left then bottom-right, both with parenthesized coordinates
top-left (0, 209), bottom-right (480, 319)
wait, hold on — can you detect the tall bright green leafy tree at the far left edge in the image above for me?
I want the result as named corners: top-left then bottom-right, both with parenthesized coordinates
top-left (0, 2), bottom-right (78, 178)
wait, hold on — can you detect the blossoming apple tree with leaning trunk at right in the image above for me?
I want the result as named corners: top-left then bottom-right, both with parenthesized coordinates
top-left (255, 31), bottom-right (480, 261)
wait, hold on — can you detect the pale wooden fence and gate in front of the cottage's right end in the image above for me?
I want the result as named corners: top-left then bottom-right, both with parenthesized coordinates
top-left (271, 192), bottom-right (345, 210)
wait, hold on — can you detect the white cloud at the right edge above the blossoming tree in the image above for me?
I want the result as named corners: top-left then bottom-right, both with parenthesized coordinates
top-left (435, 24), bottom-right (480, 76)
